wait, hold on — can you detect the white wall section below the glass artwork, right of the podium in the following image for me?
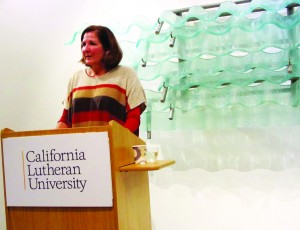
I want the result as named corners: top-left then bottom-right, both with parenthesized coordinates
top-left (142, 126), bottom-right (300, 230)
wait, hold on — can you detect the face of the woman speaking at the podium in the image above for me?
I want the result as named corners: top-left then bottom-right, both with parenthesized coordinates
top-left (81, 32), bottom-right (105, 69)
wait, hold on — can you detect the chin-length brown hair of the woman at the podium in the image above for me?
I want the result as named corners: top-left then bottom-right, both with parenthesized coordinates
top-left (80, 25), bottom-right (123, 71)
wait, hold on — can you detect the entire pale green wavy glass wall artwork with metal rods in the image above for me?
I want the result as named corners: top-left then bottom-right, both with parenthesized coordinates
top-left (119, 0), bottom-right (300, 138)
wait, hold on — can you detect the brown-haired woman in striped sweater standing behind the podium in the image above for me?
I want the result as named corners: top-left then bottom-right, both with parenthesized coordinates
top-left (57, 25), bottom-right (146, 135)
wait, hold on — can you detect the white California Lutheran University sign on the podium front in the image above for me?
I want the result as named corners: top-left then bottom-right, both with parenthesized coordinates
top-left (3, 132), bottom-right (113, 207)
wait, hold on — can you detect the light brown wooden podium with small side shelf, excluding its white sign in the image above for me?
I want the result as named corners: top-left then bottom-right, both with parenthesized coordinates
top-left (1, 121), bottom-right (175, 230)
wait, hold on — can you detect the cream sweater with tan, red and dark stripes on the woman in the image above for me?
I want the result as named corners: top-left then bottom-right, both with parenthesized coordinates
top-left (60, 66), bottom-right (146, 133)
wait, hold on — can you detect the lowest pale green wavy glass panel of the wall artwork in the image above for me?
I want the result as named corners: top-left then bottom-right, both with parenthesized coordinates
top-left (141, 103), bottom-right (300, 131)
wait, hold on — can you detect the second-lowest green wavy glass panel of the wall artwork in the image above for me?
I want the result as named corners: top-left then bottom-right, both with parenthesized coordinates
top-left (146, 81), bottom-right (300, 111)
